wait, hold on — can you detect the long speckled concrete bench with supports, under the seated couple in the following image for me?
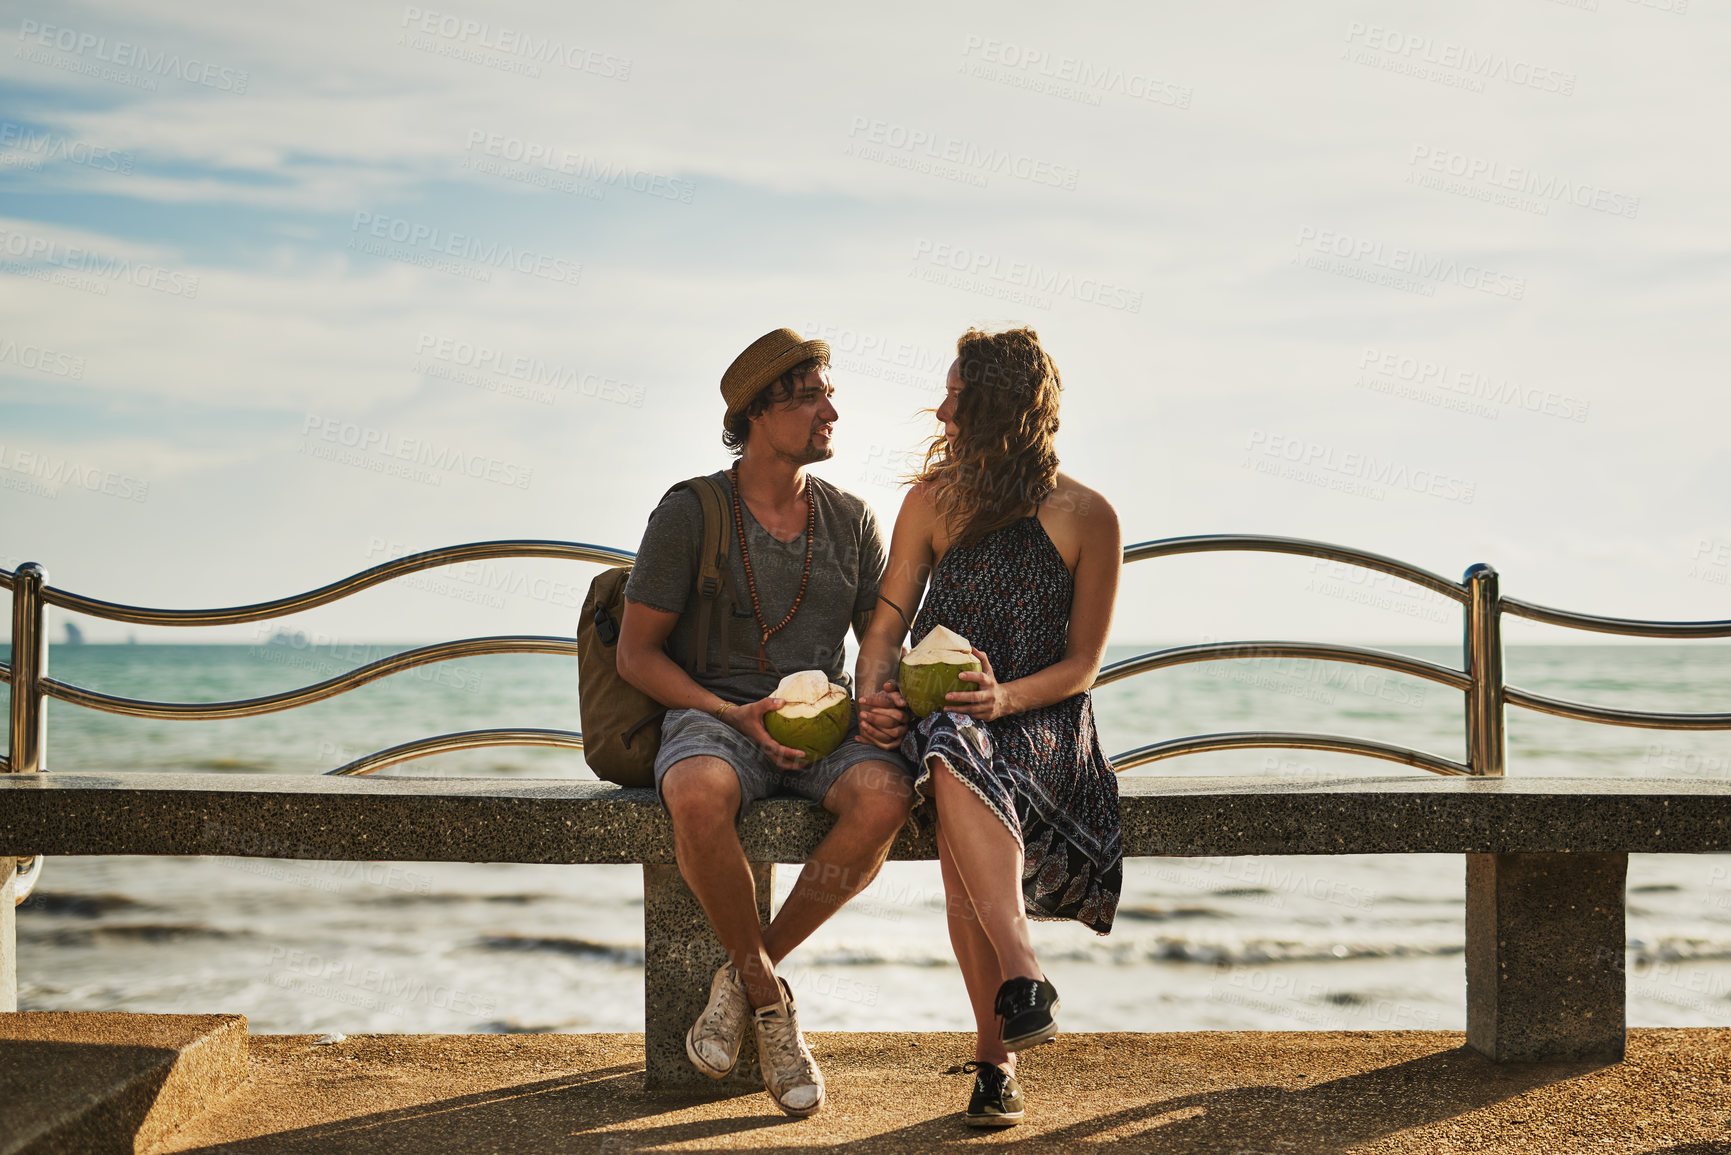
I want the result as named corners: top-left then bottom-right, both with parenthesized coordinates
top-left (0, 774), bottom-right (1731, 1086)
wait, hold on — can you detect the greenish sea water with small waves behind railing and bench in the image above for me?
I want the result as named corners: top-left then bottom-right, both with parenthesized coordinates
top-left (19, 644), bottom-right (1731, 1032)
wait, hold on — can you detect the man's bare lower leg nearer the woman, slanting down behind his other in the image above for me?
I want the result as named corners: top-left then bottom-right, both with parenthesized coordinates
top-left (761, 760), bottom-right (914, 963)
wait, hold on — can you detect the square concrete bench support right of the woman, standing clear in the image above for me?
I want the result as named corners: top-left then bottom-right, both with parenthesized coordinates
top-left (1466, 854), bottom-right (1629, 1063)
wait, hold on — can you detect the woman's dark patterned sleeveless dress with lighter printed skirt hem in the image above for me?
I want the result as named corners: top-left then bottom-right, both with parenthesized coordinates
top-left (902, 516), bottom-right (1123, 933)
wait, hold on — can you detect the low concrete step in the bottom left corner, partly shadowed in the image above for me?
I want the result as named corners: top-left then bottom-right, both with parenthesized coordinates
top-left (0, 1011), bottom-right (248, 1155)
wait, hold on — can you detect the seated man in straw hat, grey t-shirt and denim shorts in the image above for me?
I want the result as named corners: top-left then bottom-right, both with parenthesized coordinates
top-left (618, 329), bottom-right (912, 1115)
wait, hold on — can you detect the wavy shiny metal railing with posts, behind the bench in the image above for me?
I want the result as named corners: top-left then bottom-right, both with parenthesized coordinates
top-left (0, 533), bottom-right (1731, 900)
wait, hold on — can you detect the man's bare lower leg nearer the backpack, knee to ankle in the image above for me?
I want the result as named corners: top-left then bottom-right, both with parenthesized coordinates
top-left (661, 755), bottom-right (781, 1006)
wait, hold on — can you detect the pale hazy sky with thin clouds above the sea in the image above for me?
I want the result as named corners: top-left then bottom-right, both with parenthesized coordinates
top-left (0, 0), bottom-right (1731, 644)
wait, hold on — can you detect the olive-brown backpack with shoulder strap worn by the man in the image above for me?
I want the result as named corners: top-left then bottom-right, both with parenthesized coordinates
top-left (576, 476), bottom-right (732, 786)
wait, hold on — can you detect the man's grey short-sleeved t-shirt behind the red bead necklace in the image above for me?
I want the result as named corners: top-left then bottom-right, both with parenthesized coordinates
top-left (625, 473), bottom-right (885, 703)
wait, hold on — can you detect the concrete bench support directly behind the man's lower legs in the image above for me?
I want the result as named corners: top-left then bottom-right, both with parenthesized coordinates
top-left (644, 862), bottom-right (775, 1093)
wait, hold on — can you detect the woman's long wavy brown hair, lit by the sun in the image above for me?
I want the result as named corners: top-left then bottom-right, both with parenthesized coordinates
top-left (911, 329), bottom-right (1063, 545)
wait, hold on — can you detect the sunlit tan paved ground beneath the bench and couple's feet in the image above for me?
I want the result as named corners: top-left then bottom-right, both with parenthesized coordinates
top-left (156, 1030), bottom-right (1731, 1155)
